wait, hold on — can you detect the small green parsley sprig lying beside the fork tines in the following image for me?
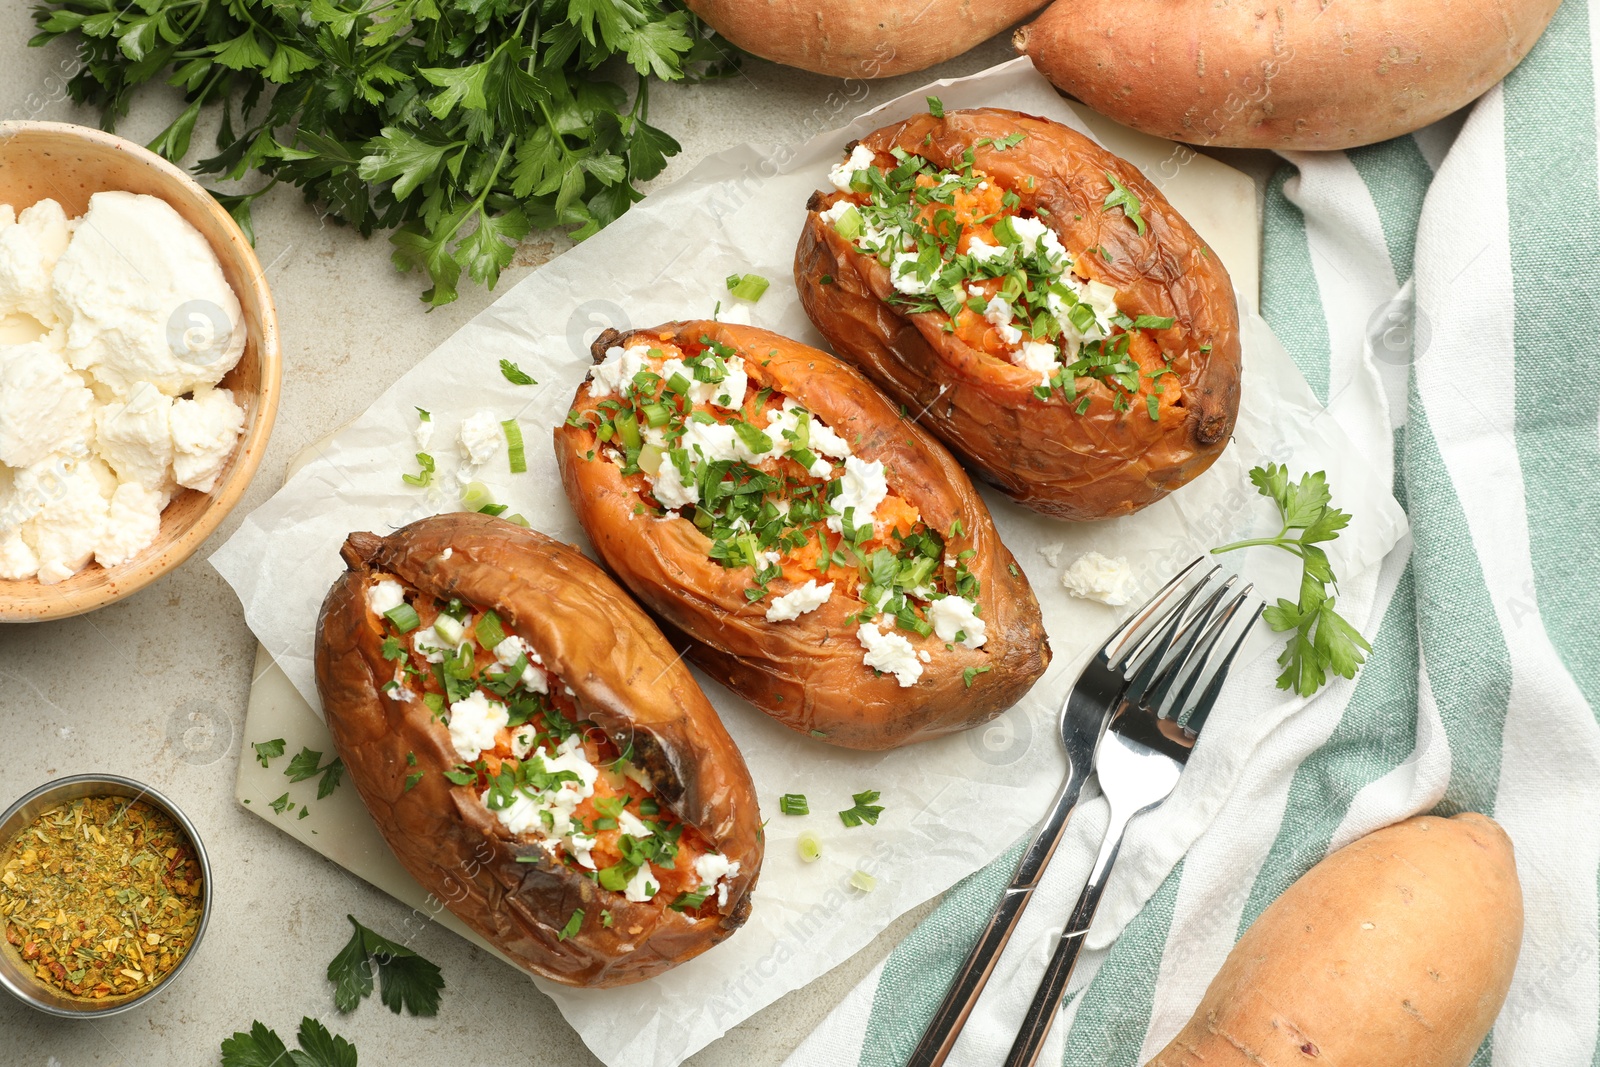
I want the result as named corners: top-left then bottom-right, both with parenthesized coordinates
top-left (1211, 464), bottom-right (1373, 696)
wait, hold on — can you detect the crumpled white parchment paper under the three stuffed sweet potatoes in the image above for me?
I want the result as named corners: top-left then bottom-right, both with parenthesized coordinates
top-left (211, 61), bottom-right (1405, 1067)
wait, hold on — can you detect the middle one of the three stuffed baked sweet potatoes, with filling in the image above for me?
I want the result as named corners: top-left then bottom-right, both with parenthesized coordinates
top-left (555, 322), bottom-right (1050, 749)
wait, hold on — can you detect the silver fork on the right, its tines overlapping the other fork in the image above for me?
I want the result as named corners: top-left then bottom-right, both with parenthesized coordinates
top-left (1005, 568), bottom-right (1266, 1067)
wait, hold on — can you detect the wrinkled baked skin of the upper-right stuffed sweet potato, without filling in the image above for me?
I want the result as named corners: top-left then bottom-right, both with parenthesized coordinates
top-left (795, 107), bottom-right (1240, 520)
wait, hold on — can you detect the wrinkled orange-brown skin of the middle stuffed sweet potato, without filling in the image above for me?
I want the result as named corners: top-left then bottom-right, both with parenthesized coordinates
top-left (555, 322), bottom-right (1050, 749)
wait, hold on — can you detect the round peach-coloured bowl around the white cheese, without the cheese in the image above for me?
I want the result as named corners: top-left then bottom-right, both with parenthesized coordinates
top-left (0, 122), bottom-right (283, 622)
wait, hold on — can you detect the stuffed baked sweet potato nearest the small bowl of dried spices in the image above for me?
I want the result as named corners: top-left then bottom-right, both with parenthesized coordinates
top-left (317, 514), bottom-right (762, 985)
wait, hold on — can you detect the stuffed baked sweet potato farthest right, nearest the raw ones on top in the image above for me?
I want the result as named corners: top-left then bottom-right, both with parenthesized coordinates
top-left (795, 109), bottom-right (1240, 520)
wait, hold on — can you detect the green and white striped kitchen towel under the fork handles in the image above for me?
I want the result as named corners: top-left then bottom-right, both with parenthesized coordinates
top-left (789, 0), bottom-right (1600, 1067)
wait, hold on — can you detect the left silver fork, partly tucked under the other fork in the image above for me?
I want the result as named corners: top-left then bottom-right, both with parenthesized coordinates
top-left (907, 560), bottom-right (1200, 1067)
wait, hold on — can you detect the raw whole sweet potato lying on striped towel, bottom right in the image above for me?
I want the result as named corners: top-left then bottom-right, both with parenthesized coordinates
top-left (1149, 813), bottom-right (1522, 1067)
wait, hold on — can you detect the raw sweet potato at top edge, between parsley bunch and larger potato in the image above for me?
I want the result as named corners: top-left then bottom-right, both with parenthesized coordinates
top-left (688, 0), bottom-right (1045, 78)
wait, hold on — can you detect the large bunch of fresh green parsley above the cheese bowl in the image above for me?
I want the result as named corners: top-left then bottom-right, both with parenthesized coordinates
top-left (30, 0), bottom-right (722, 307)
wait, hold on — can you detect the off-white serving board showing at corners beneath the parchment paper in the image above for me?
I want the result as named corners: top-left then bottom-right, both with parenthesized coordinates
top-left (234, 104), bottom-right (1261, 979)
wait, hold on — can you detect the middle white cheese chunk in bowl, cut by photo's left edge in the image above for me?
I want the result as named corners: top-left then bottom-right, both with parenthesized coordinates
top-left (0, 341), bottom-right (94, 469)
